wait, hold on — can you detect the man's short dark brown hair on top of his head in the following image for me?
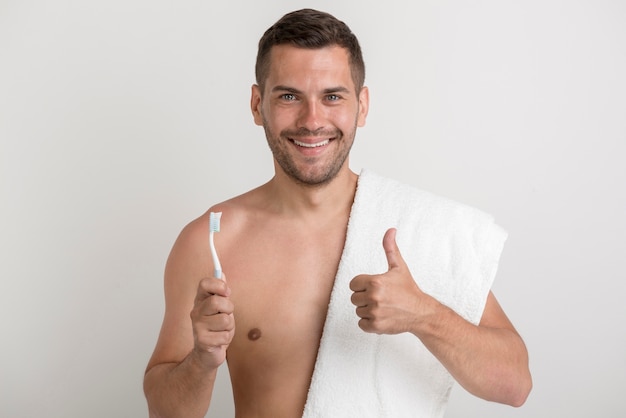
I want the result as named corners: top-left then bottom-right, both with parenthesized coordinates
top-left (255, 9), bottom-right (365, 94)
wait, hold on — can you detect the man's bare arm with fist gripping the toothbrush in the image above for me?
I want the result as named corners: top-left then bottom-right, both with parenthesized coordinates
top-left (144, 222), bottom-right (235, 417)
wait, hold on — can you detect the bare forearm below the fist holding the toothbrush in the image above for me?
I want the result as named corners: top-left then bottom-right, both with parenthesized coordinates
top-left (144, 352), bottom-right (217, 418)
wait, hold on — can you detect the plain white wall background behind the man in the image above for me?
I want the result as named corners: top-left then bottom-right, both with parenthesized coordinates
top-left (0, 0), bottom-right (626, 418)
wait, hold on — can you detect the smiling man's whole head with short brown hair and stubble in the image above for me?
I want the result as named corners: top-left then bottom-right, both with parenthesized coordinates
top-left (250, 10), bottom-right (369, 186)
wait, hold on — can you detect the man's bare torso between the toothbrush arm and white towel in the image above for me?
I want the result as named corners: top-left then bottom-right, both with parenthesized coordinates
top-left (216, 181), bottom-right (349, 418)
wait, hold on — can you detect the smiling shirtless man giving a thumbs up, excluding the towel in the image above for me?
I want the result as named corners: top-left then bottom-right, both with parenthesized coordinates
top-left (144, 10), bottom-right (531, 418)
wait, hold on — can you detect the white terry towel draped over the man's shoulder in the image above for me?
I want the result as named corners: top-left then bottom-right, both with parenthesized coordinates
top-left (303, 170), bottom-right (507, 418)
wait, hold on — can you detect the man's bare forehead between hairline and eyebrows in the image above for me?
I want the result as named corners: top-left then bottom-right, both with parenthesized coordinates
top-left (267, 45), bottom-right (354, 90)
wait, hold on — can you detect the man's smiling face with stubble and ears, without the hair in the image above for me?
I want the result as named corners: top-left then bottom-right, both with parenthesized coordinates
top-left (251, 45), bottom-right (369, 185)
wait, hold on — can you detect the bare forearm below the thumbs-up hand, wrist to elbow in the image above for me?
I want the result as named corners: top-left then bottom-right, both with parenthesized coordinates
top-left (412, 299), bottom-right (532, 406)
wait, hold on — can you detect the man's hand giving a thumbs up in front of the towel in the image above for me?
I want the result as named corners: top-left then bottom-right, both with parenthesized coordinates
top-left (350, 228), bottom-right (427, 334)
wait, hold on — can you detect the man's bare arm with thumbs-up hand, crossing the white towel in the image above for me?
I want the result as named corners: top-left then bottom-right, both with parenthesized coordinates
top-left (350, 229), bottom-right (532, 406)
